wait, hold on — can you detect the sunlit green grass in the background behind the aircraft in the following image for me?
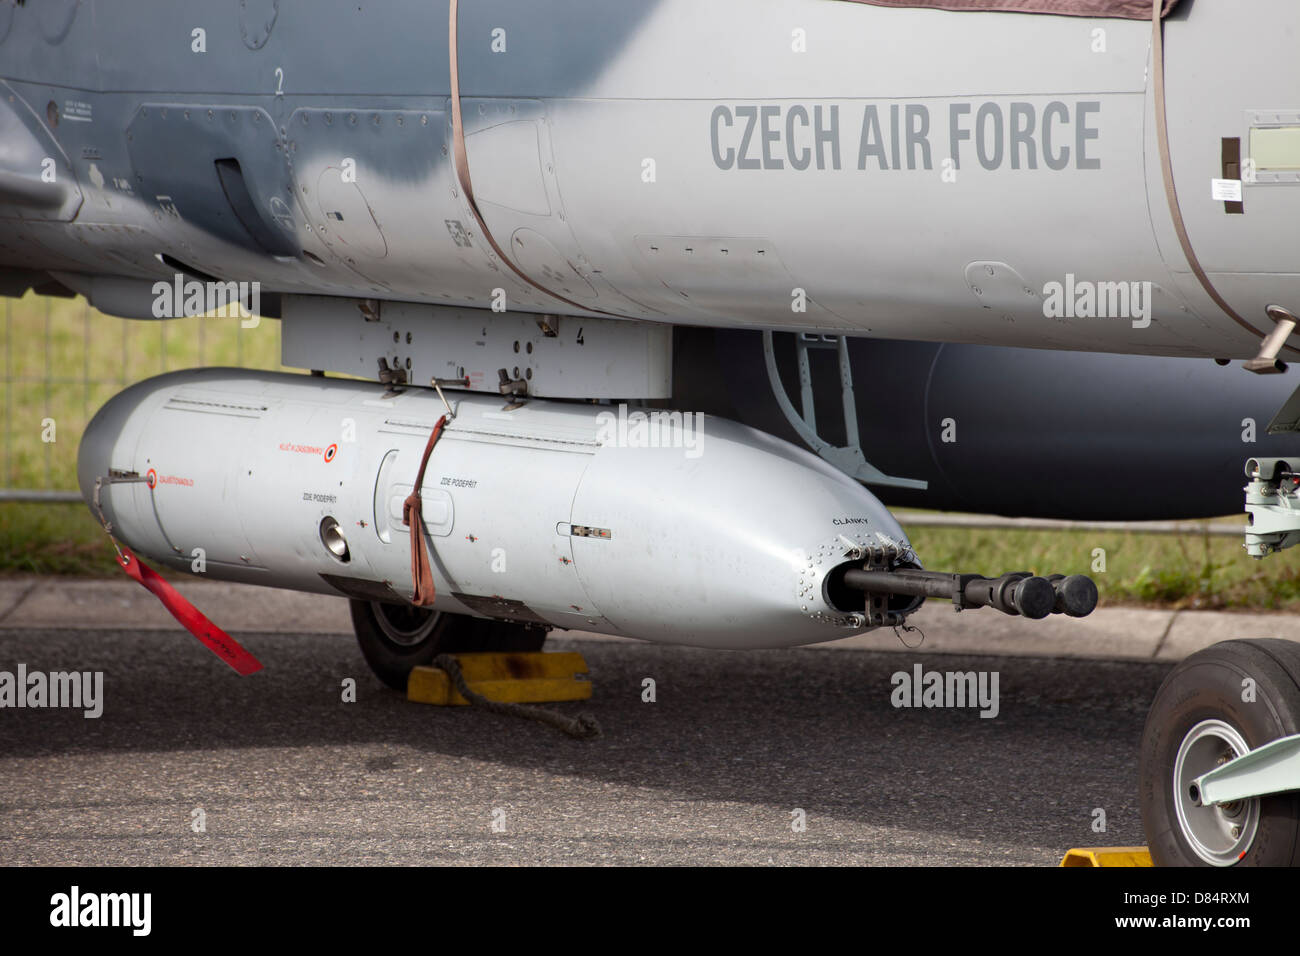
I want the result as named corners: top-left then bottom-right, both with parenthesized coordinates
top-left (0, 295), bottom-right (1300, 610)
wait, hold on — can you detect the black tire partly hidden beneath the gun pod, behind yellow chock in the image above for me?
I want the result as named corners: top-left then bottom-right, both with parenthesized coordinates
top-left (350, 600), bottom-right (549, 692)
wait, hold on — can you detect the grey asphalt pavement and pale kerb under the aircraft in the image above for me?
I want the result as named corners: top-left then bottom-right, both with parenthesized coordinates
top-left (0, 579), bottom-right (1300, 865)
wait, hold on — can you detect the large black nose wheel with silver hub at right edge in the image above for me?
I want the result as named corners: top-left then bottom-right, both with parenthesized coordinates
top-left (1139, 639), bottom-right (1300, 866)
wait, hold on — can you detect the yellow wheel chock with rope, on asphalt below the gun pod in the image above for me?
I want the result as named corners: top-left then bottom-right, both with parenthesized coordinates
top-left (407, 652), bottom-right (592, 706)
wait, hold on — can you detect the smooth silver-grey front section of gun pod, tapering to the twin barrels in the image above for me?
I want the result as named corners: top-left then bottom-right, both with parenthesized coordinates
top-left (572, 412), bottom-right (907, 648)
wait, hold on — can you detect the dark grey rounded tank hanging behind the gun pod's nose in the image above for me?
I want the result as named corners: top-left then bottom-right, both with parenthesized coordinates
top-left (673, 328), bottom-right (1300, 520)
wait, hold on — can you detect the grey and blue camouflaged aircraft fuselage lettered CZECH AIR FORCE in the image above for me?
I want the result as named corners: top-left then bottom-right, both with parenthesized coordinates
top-left (0, 0), bottom-right (1300, 358)
